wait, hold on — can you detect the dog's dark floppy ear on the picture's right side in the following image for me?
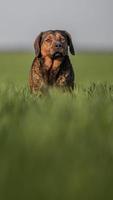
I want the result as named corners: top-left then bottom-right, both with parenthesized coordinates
top-left (63, 31), bottom-right (75, 55)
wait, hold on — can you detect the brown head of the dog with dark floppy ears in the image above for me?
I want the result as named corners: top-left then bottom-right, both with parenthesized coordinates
top-left (34, 30), bottom-right (75, 59)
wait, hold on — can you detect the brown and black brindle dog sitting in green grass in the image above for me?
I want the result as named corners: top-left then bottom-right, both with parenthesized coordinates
top-left (29, 30), bottom-right (75, 92)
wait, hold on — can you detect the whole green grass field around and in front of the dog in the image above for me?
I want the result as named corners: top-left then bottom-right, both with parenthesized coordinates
top-left (0, 53), bottom-right (113, 200)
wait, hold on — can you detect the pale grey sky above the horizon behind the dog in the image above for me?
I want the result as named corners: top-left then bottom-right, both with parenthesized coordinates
top-left (0, 0), bottom-right (113, 50)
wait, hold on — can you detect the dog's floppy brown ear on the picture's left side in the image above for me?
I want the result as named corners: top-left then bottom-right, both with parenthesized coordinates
top-left (34, 32), bottom-right (43, 58)
